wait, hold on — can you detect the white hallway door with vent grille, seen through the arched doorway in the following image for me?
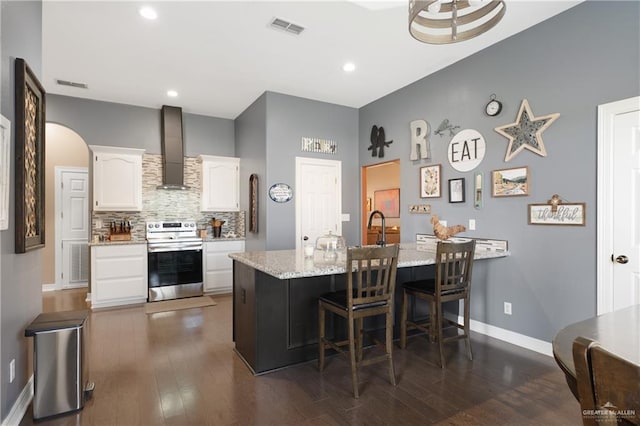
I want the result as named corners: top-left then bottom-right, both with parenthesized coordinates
top-left (59, 170), bottom-right (90, 288)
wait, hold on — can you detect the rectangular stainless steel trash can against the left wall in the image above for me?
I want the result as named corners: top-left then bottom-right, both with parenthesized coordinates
top-left (25, 310), bottom-right (93, 420)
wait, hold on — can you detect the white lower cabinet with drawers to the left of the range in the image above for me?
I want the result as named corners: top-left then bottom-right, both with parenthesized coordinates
top-left (91, 244), bottom-right (147, 309)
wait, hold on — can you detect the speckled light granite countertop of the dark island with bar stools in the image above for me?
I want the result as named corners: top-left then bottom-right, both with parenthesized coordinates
top-left (229, 243), bottom-right (510, 280)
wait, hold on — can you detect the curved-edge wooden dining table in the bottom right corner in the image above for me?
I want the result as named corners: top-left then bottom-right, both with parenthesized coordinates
top-left (553, 305), bottom-right (640, 398)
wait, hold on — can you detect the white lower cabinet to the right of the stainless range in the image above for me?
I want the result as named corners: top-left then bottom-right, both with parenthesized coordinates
top-left (202, 241), bottom-right (244, 294)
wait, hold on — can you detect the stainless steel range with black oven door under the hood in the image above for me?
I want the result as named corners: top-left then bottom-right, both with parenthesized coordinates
top-left (146, 221), bottom-right (203, 302)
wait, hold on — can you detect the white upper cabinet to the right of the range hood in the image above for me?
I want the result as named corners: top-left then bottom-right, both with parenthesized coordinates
top-left (199, 155), bottom-right (240, 212)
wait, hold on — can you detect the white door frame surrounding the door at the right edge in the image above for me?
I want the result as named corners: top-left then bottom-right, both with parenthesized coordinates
top-left (596, 96), bottom-right (640, 315)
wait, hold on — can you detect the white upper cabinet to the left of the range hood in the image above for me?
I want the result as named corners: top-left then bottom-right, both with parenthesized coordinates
top-left (89, 145), bottom-right (144, 211)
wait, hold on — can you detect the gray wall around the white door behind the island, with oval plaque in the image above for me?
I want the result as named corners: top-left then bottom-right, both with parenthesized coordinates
top-left (266, 92), bottom-right (360, 250)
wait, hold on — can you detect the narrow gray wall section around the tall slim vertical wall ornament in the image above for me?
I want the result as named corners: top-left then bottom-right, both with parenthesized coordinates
top-left (235, 93), bottom-right (269, 251)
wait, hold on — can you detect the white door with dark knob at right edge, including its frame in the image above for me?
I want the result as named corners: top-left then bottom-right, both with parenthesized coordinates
top-left (598, 97), bottom-right (640, 315)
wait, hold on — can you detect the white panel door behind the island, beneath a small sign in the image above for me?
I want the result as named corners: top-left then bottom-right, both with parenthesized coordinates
top-left (295, 157), bottom-right (342, 249)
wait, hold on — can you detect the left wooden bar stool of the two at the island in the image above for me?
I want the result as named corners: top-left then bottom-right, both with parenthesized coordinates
top-left (318, 245), bottom-right (399, 398)
